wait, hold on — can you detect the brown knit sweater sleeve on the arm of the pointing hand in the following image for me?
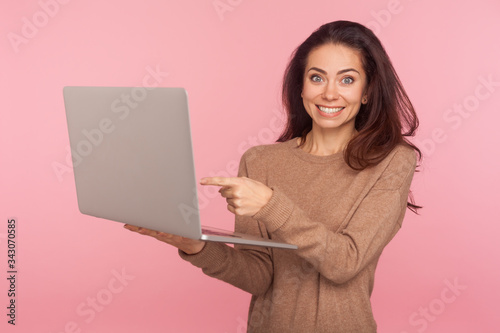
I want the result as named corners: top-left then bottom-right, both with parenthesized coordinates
top-left (254, 149), bottom-right (416, 283)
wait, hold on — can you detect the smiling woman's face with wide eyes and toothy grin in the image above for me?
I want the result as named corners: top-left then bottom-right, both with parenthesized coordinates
top-left (302, 44), bottom-right (366, 131)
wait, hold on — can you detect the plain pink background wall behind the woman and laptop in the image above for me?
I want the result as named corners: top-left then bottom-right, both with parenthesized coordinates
top-left (0, 0), bottom-right (500, 333)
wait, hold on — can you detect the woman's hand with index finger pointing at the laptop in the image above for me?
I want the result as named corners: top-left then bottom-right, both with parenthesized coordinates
top-left (200, 177), bottom-right (273, 216)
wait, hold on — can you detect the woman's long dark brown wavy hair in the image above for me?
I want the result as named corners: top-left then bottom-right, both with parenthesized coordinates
top-left (276, 21), bottom-right (422, 212)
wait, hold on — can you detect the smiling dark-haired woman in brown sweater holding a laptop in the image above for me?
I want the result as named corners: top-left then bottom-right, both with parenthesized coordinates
top-left (126, 21), bottom-right (420, 333)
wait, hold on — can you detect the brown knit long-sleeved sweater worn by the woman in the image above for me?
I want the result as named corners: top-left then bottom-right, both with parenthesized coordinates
top-left (180, 139), bottom-right (416, 333)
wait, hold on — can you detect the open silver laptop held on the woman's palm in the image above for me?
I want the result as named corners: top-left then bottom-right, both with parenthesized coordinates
top-left (63, 87), bottom-right (297, 249)
